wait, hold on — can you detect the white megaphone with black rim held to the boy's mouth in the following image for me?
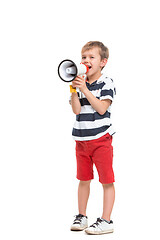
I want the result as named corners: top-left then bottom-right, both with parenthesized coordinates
top-left (58, 59), bottom-right (89, 82)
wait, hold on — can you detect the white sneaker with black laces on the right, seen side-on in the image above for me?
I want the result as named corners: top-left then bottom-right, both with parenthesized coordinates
top-left (85, 218), bottom-right (114, 234)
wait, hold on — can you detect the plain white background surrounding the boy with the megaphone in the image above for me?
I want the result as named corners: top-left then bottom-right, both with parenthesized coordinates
top-left (0, 0), bottom-right (160, 240)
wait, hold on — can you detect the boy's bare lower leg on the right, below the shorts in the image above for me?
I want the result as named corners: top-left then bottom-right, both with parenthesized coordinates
top-left (102, 183), bottom-right (115, 221)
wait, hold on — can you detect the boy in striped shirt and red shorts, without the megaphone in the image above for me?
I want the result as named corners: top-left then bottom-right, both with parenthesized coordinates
top-left (71, 41), bottom-right (115, 234)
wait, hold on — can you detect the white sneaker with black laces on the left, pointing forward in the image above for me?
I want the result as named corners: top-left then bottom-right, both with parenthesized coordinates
top-left (71, 214), bottom-right (88, 231)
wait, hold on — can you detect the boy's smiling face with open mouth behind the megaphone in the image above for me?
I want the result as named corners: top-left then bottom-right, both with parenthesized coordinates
top-left (82, 47), bottom-right (107, 77)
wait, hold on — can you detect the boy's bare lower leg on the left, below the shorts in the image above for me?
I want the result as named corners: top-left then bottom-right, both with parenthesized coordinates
top-left (78, 181), bottom-right (91, 216)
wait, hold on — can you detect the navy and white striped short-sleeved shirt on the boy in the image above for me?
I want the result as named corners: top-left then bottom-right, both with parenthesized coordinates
top-left (72, 75), bottom-right (116, 141)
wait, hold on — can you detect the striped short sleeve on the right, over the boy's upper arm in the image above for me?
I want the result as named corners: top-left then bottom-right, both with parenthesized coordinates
top-left (100, 78), bottom-right (116, 101)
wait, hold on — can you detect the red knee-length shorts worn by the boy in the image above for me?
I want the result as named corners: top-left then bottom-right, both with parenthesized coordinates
top-left (76, 133), bottom-right (115, 184)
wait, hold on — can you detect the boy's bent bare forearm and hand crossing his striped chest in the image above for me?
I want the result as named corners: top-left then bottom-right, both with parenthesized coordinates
top-left (73, 76), bottom-right (112, 115)
